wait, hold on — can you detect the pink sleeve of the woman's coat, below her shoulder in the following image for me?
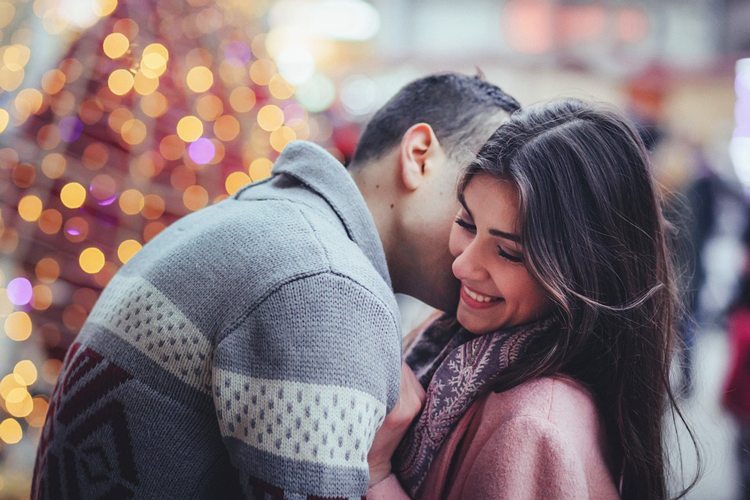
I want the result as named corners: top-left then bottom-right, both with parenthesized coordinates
top-left (461, 417), bottom-right (589, 500)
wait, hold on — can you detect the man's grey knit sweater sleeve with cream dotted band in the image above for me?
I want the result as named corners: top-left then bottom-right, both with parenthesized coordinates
top-left (213, 273), bottom-right (401, 499)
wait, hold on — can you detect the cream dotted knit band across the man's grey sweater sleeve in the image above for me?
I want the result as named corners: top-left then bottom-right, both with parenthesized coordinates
top-left (215, 370), bottom-right (386, 470)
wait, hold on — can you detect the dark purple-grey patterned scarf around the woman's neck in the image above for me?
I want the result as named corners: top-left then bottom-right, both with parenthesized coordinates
top-left (393, 316), bottom-right (557, 498)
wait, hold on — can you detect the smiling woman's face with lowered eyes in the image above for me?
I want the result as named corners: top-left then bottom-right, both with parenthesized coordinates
top-left (450, 175), bottom-right (552, 334)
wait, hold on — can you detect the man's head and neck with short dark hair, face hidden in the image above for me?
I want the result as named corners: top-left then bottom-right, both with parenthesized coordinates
top-left (349, 73), bottom-right (520, 312)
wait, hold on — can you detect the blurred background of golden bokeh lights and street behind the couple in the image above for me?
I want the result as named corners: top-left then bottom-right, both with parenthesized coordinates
top-left (0, 0), bottom-right (750, 500)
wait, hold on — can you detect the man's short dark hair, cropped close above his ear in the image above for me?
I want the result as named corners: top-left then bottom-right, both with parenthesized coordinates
top-left (352, 73), bottom-right (521, 165)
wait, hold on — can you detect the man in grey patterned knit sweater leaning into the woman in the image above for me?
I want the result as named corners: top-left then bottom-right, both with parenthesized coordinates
top-left (33, 73), bottom-right (518, 499)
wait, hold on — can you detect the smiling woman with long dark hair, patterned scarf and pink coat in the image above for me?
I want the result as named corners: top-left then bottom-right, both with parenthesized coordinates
top-left (368, 100), bottom-right (696, 499)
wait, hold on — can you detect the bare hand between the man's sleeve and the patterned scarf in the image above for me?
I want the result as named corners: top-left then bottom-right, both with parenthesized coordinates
top-left (367, 363), bottom-right (426, 486)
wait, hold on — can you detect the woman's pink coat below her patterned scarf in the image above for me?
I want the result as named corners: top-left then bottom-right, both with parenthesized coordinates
top-left (367, 377), bottom-right (619, 500)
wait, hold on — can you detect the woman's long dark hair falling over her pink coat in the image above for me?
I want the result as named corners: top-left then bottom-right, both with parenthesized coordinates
top-left (459, 100), bottom-right (704, 500)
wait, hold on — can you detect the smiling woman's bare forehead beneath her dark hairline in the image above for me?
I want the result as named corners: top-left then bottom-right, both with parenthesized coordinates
top-left (464, 175), bottom-right (519, 233)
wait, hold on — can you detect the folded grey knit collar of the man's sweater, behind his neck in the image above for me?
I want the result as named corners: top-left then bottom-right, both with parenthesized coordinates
top-left (273, 141), bottom-right (393, 288)
